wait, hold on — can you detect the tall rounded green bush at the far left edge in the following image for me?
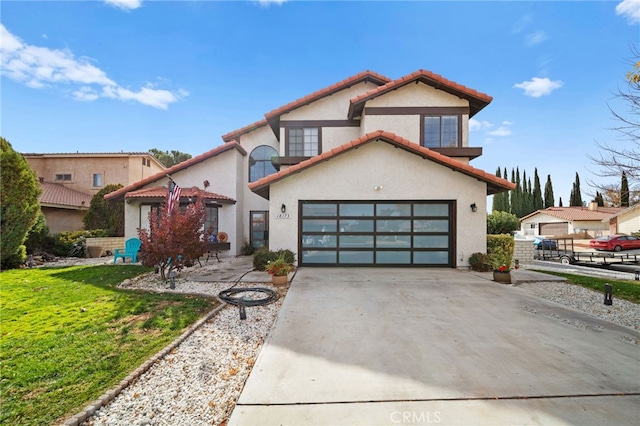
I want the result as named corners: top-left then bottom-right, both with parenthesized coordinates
top-left (0, 137), bottom-right (41, 269)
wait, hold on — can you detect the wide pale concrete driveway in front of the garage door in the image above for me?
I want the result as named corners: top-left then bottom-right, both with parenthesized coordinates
top-left (229, 268), bottom-right (640, 425)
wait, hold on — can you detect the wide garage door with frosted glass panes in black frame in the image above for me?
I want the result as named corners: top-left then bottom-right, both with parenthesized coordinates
top-left (298, 201), bottom-right (455, 267)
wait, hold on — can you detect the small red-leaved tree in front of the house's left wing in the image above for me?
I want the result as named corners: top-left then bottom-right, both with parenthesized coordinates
top-left (138, 190), bottom-right (209, 280)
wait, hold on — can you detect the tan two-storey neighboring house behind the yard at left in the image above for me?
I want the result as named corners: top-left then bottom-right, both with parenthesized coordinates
top-left (22, 152), bottom-right (165, 233)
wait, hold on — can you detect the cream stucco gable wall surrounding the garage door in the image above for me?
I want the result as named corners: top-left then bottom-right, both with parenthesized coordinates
top-left (269, 142), bottom-right (487, 267)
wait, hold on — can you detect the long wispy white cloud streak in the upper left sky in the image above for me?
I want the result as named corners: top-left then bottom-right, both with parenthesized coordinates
top-left (0, 24), bottom-right (188, 109)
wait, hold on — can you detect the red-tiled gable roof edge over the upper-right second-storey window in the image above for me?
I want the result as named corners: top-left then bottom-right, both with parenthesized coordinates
top-left (348, 69), bottom-right (493, 119)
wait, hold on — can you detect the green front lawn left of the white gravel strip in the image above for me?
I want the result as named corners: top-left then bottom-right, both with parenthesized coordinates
top-left (0, 265), bottom-right (217, 425)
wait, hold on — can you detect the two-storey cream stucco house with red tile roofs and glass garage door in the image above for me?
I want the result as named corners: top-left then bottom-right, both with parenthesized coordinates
top-left (105, 70), bottom-right (515, 268)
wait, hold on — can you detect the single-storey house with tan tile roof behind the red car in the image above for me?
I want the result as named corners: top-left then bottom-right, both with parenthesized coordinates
top-left (520, 202), bottom-right (622, 238)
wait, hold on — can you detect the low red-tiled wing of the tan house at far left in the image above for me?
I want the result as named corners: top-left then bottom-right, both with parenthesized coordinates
top-left (40, 180), bottom-right (91, 234)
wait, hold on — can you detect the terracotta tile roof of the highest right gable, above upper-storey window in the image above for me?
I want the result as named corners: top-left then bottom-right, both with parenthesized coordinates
top-left (348, 70), bottom-right (493, 119)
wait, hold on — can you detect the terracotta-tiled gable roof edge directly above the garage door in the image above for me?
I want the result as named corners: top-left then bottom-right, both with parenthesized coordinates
top-left (249, 130), bottom-right (515, 198)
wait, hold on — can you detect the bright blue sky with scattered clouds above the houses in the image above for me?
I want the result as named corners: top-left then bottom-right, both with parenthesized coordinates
top-left (0, 0), bottom-right (640, 205)
